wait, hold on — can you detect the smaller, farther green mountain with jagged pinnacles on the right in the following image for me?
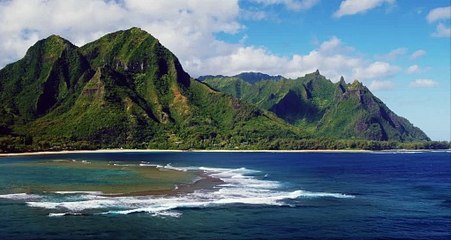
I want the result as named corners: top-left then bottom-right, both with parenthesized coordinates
top-left (204, 71), bottom-right (429, 141)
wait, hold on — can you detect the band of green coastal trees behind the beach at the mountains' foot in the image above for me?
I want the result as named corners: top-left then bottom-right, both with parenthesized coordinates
top-left (0, 136), bottom-right (451, 154)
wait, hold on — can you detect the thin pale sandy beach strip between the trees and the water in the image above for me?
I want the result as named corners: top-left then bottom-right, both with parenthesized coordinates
top-left (0, 149), bottom-right (378, 157)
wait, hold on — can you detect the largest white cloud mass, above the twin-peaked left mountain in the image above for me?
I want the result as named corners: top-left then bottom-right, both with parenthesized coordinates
top-left (0, 0), bottom-right (243, 66)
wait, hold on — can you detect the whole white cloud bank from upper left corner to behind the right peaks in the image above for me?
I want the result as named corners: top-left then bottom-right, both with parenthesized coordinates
top-left (0, 0), bottom-right (399, 89)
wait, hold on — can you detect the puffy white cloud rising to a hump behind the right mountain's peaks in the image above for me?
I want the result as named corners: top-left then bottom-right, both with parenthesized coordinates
top-left (190, 37), bottom-right (356, 80)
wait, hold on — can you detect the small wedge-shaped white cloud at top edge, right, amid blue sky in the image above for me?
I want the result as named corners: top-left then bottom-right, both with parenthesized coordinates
top-left (334, 0), bottom-right (395, 18)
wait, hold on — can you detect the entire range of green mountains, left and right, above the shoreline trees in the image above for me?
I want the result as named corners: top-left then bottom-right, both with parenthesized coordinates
top-left (0, 27), bottom-right (434, 151)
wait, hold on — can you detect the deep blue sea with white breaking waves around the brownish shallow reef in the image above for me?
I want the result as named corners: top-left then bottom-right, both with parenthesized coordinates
top-left (0, 151), bottom-right (451, 239)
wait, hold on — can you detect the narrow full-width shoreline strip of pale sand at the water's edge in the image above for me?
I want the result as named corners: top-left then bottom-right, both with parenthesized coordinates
top-left (0, 148), bottom-right (451, 157)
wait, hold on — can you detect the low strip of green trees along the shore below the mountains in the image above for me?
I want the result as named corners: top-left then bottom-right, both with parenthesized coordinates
top-left (0, 134), bottom-right (451, 152)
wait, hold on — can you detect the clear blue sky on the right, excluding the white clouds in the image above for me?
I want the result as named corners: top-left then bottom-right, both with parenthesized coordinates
top-left (233, 0), bottom-right (451, 140)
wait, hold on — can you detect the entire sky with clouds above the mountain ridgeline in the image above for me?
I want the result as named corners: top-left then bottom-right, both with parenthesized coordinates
top-left (0, 0), bottom-right (451, 141)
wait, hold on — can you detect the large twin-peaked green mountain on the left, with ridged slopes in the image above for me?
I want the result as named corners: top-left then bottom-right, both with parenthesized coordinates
top-left (0, 28), bottom-right (302, 149)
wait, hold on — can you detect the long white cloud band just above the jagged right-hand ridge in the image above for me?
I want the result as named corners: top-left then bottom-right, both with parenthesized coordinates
top-left (186, 37), bottom-right (400, 90)
